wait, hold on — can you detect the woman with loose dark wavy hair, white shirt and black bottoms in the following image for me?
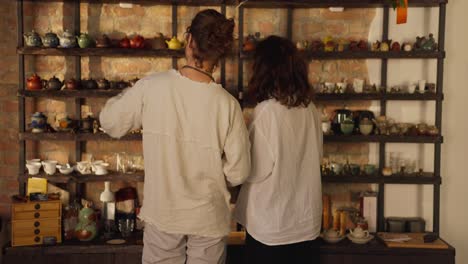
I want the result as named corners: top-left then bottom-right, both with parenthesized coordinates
top-left (235, 36), bottom-right (322, 263)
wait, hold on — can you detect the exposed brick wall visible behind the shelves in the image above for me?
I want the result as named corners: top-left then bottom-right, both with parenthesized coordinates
top-left (0, 1), bottom-right (375, 219)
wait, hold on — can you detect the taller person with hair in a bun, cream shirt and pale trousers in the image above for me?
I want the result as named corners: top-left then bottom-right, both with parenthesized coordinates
top-left (100, 9), bottom-right (250, 264)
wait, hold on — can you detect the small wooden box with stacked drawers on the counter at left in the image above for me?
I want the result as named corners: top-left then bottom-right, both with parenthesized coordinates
top-left (11, 200), bottom-right (62, 247)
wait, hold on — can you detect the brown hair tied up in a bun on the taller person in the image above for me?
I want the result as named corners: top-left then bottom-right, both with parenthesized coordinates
top-left (187, 9), bottom-right (234, 67)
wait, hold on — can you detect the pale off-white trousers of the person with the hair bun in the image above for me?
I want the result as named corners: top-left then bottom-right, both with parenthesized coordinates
top-left (142, 224), bottom-right (226, 264)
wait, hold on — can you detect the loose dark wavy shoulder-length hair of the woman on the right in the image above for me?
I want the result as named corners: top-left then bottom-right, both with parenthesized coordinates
top-left (247, 36), bottom-right (313, 108)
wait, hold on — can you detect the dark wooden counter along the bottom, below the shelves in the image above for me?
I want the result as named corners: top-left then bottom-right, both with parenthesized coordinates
top-left (4, 234), bottom-right (455, 264)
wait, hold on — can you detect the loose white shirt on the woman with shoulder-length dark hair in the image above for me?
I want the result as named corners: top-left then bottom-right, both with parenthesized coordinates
top-left (234, 99), bottom-right (322, 245)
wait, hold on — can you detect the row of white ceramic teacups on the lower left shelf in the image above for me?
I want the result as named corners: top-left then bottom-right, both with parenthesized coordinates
top-left (26, 159), bottom-right (109, 175)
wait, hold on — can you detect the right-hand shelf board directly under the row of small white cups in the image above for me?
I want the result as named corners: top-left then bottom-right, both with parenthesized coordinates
top-left (315, 93), bottom-right (444, 101)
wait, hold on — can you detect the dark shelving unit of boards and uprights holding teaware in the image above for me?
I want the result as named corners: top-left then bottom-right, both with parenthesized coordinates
top-left (17, 0), bottom-right (447, 235)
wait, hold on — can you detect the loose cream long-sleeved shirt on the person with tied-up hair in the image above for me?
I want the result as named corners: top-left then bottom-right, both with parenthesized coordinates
top-left (100, 70), bottom-right (250, 237)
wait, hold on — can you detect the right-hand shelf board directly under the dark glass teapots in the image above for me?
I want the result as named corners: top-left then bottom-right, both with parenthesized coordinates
top-left (324, 135), bottom-right (443, 143)
